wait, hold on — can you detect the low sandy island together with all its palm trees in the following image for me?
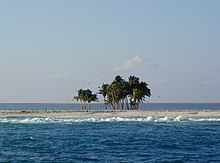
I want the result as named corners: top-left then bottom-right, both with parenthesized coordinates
top-left (0, 75), bottom-right (220, 117)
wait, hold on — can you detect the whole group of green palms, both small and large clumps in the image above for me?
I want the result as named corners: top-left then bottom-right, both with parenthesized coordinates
top-left (73, 75), bottom-right (151, 110)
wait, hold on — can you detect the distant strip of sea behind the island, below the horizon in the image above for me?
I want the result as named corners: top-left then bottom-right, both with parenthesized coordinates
top-left (0, 103), bottom-right (220, 110)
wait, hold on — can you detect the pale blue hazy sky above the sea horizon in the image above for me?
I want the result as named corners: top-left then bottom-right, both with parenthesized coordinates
top-left (0, 0), bottom-right (220, 103)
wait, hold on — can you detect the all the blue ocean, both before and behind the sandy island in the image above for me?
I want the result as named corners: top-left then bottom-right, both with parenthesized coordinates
top-left (0, 104), bottom-right (220, 163)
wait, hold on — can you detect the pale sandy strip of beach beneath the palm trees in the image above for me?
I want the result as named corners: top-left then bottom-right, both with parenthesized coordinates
top-left (0, 110), bottom-right (220, 117)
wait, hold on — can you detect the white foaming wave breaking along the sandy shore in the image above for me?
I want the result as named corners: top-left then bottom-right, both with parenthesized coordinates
top-left (0, 116), bottom-right (220, 124)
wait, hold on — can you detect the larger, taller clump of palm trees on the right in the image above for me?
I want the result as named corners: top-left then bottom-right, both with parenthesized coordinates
top-left (100, 75), bottom-right (151, 110)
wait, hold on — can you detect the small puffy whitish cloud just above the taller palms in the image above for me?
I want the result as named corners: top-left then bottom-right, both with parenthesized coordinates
top-left (113, 55), bottom-right (142, 72)
